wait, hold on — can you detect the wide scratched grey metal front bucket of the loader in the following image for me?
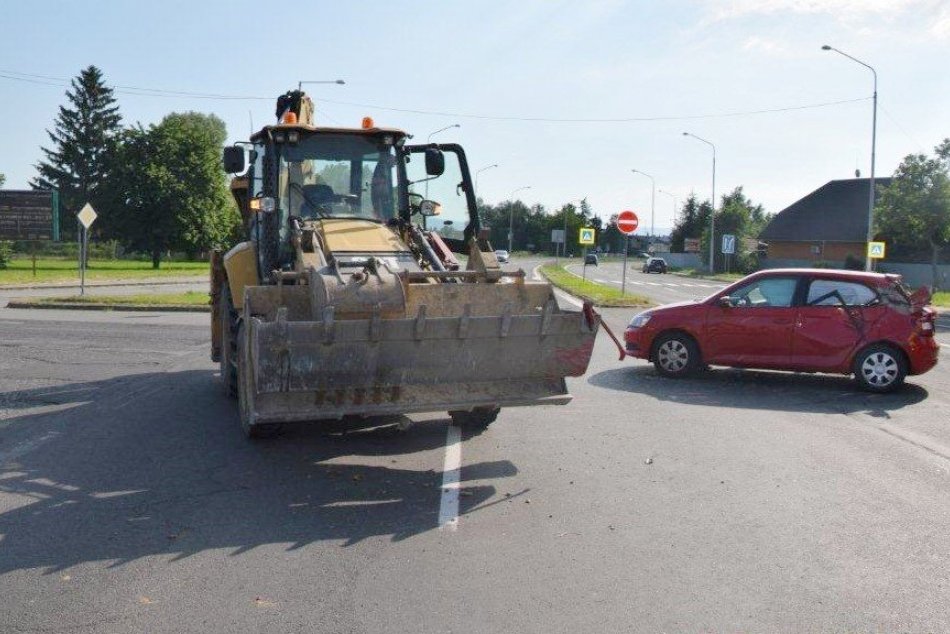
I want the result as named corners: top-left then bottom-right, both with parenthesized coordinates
top-left (240, 300), bottom-right (600, 425)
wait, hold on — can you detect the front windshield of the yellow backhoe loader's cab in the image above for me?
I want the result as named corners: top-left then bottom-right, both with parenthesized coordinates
top-left (278, 134), bottom-right (396, 226)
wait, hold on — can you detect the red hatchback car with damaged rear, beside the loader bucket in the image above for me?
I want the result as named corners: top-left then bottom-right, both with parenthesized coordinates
top-left (624, 269), bottom-right (940, 392)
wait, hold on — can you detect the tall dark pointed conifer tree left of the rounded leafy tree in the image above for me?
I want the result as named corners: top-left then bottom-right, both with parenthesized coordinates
top-left (30, 66), bottom-right (122, 239)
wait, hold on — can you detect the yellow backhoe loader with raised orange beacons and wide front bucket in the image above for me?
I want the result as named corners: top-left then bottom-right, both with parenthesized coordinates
top-left (211, 91), bottom-right (600, 437)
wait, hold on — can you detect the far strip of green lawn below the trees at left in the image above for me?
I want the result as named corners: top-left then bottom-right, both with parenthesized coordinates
top-left (0, 258), bottom-right (208, 285)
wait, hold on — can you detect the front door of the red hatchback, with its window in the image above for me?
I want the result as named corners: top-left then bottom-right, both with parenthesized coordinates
top-left (703, 275), bottom-right (801, 368)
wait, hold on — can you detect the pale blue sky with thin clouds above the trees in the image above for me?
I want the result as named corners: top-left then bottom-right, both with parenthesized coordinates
top-left (0, 0), bottom-right (950, 229)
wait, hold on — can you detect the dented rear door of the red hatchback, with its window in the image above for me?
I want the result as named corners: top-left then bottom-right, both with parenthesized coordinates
top-left (792, 278), bottom-right (879, 372)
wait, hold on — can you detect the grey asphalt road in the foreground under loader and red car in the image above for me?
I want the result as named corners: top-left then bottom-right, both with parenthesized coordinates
top-left (0, 260), bottom-right (950, 632)
